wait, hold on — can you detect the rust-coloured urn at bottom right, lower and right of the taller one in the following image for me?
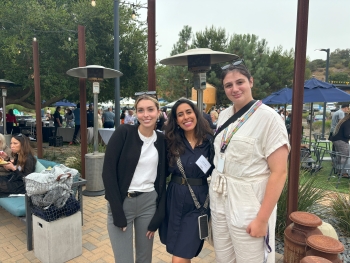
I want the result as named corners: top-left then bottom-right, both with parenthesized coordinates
top-left (306, 235), bottom-right (344, 263)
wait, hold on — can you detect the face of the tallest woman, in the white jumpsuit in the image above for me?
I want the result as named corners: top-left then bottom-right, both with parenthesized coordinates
top-left (223, 70), bottom-right (253, 110)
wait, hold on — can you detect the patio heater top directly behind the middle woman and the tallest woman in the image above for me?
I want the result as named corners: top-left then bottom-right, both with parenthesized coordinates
top-left (160, 48), bottom-right (238, 112)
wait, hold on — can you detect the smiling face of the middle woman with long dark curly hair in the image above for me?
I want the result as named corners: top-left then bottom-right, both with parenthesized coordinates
top-left (176, 103), bottom-right (197, 132)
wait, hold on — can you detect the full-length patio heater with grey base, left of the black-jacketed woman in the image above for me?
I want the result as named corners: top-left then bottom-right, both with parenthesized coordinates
top-left (67, 65), bottom-right (123, 196)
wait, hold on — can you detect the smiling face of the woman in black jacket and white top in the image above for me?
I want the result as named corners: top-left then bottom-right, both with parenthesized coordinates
top-left (136, 99), bottom-right (159, 129)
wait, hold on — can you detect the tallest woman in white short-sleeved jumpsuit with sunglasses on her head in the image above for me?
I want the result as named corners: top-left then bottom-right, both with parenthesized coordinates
top-left (209, 61), bottom-right (290, 263)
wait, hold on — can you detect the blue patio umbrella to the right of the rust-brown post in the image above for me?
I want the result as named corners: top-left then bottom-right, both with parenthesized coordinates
top-left (304, 78), bottom-right (350, 103)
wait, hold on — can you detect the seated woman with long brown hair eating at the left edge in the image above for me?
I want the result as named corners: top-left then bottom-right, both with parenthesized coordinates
top-left (0, 134), bottom-right (36, 195)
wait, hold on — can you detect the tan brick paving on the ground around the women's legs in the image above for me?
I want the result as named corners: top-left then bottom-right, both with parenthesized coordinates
top-left (0, 196), bottom-right (282, 263)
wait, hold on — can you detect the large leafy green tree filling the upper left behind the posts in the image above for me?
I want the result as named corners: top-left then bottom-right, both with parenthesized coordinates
top-left (0, 0), bottom-right (147, 108)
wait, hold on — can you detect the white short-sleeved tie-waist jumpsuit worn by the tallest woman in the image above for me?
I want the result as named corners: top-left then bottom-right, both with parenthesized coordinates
top-left (209, 104), bottom-right (290, 263)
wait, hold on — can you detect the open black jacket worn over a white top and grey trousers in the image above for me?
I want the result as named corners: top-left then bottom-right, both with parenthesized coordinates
top-left (102, 125), bottom-right (168, 231)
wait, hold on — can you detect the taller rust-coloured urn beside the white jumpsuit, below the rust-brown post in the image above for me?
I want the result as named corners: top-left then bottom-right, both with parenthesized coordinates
top-left (283, 211), bottom-right (322, 263)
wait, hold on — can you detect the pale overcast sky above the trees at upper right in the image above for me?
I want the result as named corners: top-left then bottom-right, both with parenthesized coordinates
top-left (137, 0), bottom-right (350, 61)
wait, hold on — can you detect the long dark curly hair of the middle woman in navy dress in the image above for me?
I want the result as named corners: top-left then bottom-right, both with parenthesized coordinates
top-left (165, 99), bottom-right (213, 166)
